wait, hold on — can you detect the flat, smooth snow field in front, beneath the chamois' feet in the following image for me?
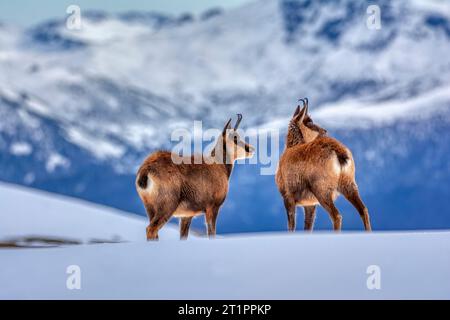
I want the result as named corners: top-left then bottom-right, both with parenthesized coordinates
top-left (0, 232), bottom-right (450, 299)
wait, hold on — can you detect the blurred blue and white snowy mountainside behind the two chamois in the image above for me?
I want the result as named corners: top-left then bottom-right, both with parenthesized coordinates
top-left (0, 0), bottom-right (450, 232)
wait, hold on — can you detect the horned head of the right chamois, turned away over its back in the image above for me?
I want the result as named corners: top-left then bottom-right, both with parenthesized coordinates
top-left (286, 98), bottom-right (327, 148)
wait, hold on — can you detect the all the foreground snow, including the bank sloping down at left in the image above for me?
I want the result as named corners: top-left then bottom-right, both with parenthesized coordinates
top-left (0, 183), bottom-right (450, 299)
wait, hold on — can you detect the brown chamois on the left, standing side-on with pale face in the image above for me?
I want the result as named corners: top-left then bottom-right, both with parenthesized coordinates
top-left (136, 114), bottom-right (254, 240)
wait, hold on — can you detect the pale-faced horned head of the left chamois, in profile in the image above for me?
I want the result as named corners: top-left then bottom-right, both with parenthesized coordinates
top-left (218, 114), bottom-right (255, 162)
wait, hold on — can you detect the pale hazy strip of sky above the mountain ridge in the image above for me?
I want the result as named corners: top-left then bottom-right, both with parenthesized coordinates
top-left (0, 0), bottom-right (249, 26)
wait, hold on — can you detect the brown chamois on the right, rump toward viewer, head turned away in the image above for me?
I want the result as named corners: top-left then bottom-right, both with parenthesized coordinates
top-left (276, 98), bottom-right (371, 231)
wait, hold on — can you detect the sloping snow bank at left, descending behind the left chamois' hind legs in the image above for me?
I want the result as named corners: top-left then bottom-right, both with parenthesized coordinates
top-left (0, 183), bottom-right (178, 245)
